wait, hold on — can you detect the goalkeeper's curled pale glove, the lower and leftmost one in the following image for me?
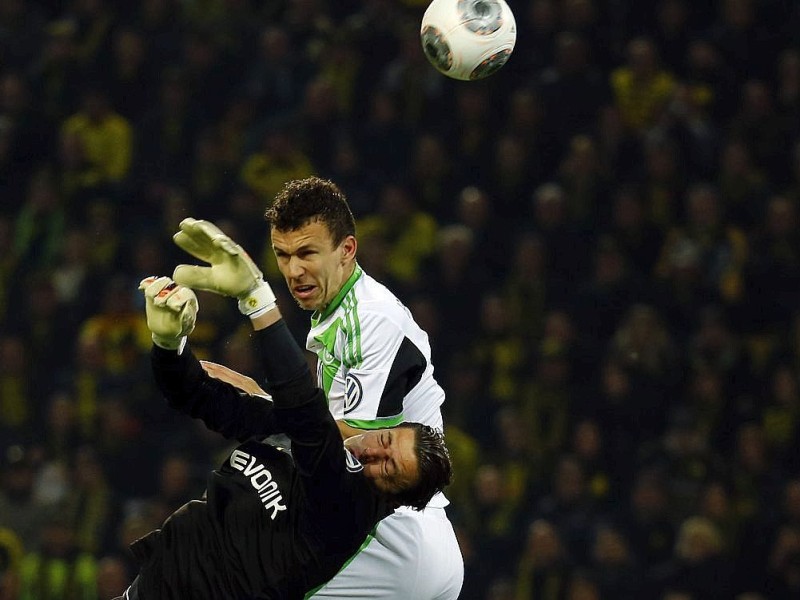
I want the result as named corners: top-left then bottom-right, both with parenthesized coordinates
top-left (139, 277), bottom-right (198, 350)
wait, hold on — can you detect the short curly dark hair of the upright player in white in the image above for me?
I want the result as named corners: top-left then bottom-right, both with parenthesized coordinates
top-left (264, 177), bottom-right (356, 246)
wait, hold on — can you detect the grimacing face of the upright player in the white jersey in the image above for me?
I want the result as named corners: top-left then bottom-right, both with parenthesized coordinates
top-left (272, 221), bottom-right (356, 310)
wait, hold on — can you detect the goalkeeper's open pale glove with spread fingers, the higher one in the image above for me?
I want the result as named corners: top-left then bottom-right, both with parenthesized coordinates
top-left (172, 218), bottom-right (276, 319)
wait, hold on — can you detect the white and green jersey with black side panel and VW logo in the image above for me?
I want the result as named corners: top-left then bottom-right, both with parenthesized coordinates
top-left (306, 265), bottom-right (444, 430)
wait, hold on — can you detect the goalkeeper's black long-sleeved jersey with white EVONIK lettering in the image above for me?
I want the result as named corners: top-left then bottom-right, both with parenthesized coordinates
top-left (131, 348), bottom-right (391, 600)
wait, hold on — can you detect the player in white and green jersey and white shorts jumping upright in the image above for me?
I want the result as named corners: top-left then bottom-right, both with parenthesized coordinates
top-left (174, 177), bottom-right (464, 600)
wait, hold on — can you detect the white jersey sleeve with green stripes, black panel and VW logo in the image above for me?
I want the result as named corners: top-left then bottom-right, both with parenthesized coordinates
top-left (329, 309), bottom-right (427, 429)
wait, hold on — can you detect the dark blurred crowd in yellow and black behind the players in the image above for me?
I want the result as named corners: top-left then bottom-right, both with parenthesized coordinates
top-left (0, 0), bottom-right (800, 600)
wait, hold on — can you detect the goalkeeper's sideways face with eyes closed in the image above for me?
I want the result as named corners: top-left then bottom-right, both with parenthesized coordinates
top-left (344, 427), bottom-right (419, 493)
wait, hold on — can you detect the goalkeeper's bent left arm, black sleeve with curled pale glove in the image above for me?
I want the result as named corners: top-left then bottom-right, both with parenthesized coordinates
top-left (140, 277), bottom-right (276, 441)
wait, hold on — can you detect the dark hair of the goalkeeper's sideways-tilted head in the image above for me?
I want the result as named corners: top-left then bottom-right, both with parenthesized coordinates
top-left (392, 423), bottom-right (453, 510)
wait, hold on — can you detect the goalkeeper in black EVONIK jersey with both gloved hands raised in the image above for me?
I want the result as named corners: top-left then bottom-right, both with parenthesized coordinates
top-left (122, 264), bottom-right (451, 600)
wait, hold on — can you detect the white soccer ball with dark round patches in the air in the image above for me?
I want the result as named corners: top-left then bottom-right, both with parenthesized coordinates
top-left (420, 0), bottom-right (517, 81)
